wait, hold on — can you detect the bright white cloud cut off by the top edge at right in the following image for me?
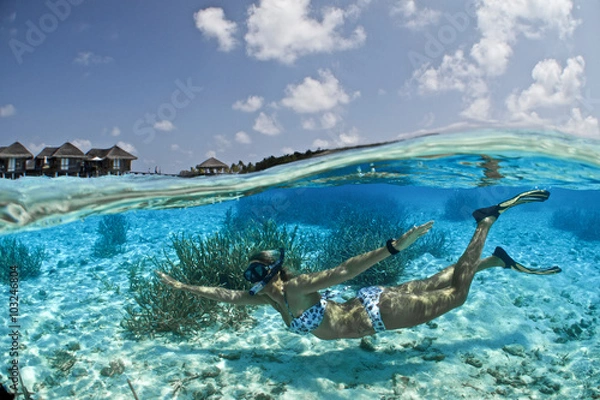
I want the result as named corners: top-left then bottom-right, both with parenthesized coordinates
top-left (471, 0), bottom-right (579, 76)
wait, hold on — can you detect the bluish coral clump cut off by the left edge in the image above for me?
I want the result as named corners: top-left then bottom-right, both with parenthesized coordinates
top-left (0, 238), bottom-right (46, 283)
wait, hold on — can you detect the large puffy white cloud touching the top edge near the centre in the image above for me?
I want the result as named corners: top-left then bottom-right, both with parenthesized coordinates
top-left (245, 0), bottom-right (366, 64)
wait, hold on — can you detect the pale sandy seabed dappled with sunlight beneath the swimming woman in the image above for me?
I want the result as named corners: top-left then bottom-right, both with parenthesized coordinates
top-left (0, 206), bottom-right (600, 399)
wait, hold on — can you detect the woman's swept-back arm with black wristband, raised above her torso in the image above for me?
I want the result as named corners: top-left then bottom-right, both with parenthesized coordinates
top-left (287, 221), bottom-right (433, 294)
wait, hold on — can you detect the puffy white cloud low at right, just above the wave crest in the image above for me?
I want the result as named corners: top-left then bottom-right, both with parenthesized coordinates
top-left (506, 56), bottom-right (585, 113)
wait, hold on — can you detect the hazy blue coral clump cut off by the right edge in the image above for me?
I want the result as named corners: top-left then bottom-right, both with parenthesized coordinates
top-left (550, 208), bottom-right (600, 242)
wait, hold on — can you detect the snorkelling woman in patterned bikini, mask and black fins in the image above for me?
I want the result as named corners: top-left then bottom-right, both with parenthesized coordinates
top-left (156, 190), bottom-right (561, 340)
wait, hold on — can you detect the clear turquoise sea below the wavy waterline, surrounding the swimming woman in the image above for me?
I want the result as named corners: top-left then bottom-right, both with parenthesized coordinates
top-left (0, 130), bottom-right (600, 399)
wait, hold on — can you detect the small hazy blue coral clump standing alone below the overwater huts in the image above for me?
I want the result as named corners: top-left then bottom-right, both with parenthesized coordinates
top-left (94, 214), bottom-right (129, 258)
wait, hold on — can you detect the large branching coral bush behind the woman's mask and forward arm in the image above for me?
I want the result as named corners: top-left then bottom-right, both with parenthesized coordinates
top-left (121, 214), bottom-right (302, 339)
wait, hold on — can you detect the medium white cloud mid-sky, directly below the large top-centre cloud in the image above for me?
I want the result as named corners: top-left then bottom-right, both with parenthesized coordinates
top-left (281, 70), bottom-right (360, 113)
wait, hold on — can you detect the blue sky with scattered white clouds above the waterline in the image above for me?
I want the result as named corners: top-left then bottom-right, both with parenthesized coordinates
top-left (0, 0), bottom-right (600, 173)
